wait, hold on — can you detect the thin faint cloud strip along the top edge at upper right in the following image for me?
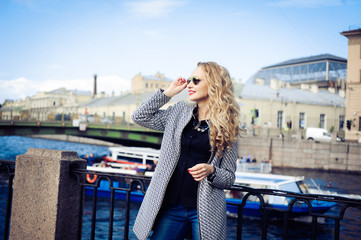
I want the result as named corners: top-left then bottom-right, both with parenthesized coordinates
top-left (270, 0), bottom-right (346, 8)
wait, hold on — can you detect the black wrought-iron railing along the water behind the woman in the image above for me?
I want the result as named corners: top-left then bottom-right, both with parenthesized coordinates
top-left (0, 158), bottom-right (361, 239)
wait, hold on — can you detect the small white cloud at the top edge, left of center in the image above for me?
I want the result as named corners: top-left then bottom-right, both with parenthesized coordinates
top-left (126, 0), bottom-right (186, 18)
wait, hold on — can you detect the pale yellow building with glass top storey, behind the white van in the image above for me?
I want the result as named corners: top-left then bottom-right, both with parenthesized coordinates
top-left (238, 54), bottom-right (347, 138)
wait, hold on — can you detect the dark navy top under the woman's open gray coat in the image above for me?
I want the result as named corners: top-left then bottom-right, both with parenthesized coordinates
top-left (163, 117), bottom-right (211, 208)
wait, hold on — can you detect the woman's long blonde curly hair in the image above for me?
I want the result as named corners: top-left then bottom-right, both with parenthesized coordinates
top-left (198, 62), bottom-right (240, 157)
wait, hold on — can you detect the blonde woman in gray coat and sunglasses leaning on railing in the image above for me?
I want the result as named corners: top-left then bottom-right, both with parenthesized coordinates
top-left (132, 62), bottom-right (239, 240)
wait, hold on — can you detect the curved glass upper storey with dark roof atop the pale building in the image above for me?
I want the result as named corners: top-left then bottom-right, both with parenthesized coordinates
top-left (248, 54), bottom-right (347, 87)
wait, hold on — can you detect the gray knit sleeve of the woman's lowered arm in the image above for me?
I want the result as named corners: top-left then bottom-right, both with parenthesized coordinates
top-left (210, 141), bottom-right (238, 189)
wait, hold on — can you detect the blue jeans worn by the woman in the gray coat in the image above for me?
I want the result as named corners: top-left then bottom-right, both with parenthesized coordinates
top-left (151, 205), bottom-right (200, 240)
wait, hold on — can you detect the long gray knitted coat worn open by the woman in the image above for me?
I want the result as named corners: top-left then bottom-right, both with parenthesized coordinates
top-left (132, 90), bottom-right (238, 240)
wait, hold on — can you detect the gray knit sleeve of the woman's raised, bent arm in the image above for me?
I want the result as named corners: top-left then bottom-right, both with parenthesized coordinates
top-left (132, 90), bottom-right (171, 131)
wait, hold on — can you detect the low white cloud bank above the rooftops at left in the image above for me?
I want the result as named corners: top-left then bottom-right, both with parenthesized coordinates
top-left (0, 75), bottom-right (131, 103)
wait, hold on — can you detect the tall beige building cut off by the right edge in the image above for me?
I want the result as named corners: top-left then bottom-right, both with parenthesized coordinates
top-left (341, 29), bottom-right (361, 141)
